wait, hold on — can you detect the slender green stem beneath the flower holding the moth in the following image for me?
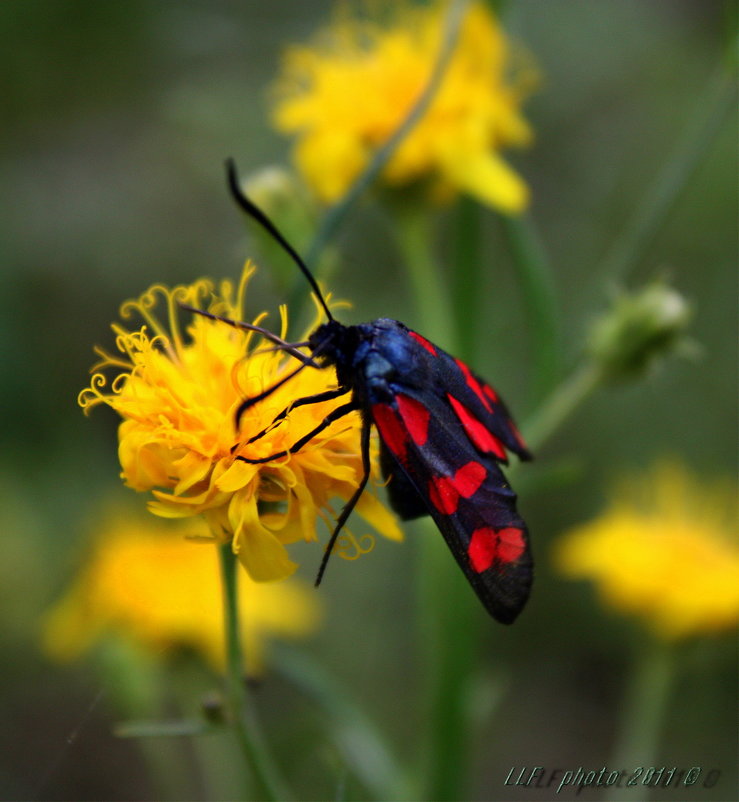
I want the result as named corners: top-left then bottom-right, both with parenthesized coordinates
top-left (219, 543), bottom-right (291, 802)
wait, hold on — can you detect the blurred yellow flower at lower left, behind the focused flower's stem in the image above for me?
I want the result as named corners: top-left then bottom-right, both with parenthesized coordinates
top-left (43, 510), bottom-right (319, 673)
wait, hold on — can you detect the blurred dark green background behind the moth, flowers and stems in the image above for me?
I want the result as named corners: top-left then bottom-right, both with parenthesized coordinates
top-left (0, 0), bottom-right (737, 800)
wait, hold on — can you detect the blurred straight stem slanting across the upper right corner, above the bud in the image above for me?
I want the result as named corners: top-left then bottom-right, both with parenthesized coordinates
top-left (597, 64), bottom-right (736, 287)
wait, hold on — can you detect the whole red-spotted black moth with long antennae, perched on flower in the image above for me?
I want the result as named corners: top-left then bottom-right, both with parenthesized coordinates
top-left (185, 161), bottom-right (533, 624)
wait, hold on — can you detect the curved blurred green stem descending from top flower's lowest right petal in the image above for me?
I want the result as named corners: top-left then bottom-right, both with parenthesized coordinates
top-left (500, 215), bottom-right (562, 400)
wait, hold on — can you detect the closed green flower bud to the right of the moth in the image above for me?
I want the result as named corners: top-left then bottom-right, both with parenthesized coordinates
top-left (588, 280), bottom-right (692, 379)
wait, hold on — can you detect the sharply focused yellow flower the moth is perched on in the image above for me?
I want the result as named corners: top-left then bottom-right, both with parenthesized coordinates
top-left (79, 265), bottom-right (402, 581)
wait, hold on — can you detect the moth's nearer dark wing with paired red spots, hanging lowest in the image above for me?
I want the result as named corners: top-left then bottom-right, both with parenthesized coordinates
top-left (370, 382), bottom-right (533, 624)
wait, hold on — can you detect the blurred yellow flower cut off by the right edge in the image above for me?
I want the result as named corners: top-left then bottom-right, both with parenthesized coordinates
top-left (555, 463), bottom-right (739, 639)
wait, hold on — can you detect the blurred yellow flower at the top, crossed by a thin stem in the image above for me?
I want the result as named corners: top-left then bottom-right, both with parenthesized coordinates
top-left (274, 2), bottom-right (535, 213)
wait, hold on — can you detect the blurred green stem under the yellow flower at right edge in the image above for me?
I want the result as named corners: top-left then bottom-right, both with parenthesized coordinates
top-left (611, 638), bottom-right (675, 800)
